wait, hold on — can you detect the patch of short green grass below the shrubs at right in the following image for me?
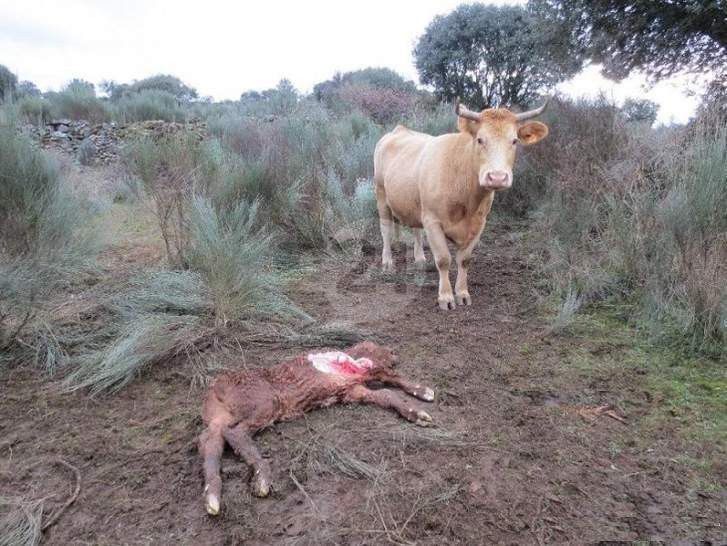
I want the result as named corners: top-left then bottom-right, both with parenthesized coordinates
top-left (564, 304), bottom-right (727, 450)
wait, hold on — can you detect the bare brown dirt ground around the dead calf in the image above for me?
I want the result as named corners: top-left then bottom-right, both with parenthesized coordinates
top-left (0, 218), bottom-right (727, 545)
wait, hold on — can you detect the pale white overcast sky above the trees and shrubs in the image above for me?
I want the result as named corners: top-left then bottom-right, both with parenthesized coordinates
top-left (0, 0), bottom-right (698, 122)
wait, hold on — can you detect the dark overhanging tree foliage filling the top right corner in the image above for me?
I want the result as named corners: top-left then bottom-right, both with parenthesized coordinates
top-left (528, 0), bottom-right (727, 80)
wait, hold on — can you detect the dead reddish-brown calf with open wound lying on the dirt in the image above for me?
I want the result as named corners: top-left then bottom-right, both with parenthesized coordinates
top-left (199, 342), bottom-right (434, 515)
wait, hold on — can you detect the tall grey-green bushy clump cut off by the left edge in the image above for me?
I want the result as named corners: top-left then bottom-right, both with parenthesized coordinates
top-left (0, 127), bottom-right (98, 354)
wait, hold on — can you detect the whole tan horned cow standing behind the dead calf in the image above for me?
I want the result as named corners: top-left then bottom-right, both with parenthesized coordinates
top-left (374, 102), bottom-right (548, 310)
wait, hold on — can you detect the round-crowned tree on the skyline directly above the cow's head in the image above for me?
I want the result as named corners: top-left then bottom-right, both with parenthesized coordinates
top-left (414, 4), bottom-right (582, 108)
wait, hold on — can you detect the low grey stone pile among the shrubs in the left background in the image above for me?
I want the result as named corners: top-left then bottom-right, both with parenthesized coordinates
top-left (24, 119), bottom-right (207, 165)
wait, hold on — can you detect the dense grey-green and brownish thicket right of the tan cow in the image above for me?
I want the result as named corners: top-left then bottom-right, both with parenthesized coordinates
top-left (532, 96), bottom-right (727, 355)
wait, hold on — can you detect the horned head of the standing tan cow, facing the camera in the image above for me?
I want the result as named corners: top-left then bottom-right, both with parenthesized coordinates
top-left (455, 101), bottom-right (548, 190)
